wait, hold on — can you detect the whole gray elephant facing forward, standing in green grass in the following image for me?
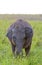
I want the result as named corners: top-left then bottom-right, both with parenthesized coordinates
top-left (6, 19), bottom-right (33, 55)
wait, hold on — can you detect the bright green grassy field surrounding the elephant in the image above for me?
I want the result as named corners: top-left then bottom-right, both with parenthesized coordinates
top-left (0, 20), bottom-right (42, 65)
